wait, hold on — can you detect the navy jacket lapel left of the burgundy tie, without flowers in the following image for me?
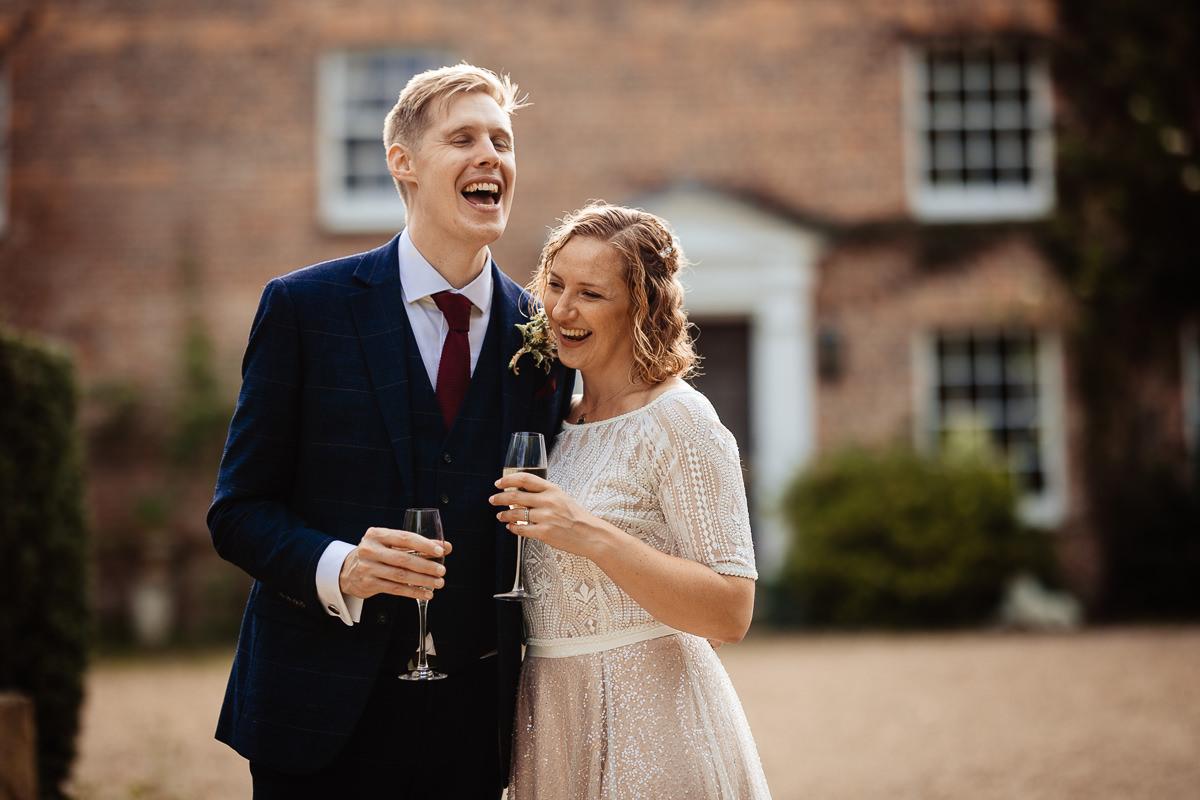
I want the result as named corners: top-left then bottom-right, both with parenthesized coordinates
top-left (349, 236), bottom-right (413, 493)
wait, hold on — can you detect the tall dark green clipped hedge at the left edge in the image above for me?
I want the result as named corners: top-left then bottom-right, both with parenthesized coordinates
top-left (0, 331), bottom-right (90, 798)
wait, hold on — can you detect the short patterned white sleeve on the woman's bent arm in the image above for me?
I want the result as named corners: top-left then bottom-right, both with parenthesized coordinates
top-left (655, 391), bottom-right (758, 579)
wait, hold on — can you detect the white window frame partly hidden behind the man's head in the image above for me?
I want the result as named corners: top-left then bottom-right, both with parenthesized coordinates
top-left (316, 48), bottom-right (452, 233)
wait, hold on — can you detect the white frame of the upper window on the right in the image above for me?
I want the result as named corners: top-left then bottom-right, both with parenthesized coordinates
top-left (901, 40), bottom-right (1055, 222)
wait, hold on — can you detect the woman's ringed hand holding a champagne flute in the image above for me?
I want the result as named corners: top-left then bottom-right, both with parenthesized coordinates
top-left (487, 473), bottom-right (594, 557)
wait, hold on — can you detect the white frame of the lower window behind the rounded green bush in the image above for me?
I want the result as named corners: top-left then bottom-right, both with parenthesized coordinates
top-left (912, 327), bottom-right (1068, 528)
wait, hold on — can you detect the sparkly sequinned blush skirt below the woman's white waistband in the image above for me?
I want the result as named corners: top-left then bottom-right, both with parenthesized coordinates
top-left (508, 633), bottom-right (770, 800)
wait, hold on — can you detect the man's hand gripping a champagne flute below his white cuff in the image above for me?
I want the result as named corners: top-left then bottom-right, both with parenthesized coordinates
top-left (337, 528), bottom-right (451, 600)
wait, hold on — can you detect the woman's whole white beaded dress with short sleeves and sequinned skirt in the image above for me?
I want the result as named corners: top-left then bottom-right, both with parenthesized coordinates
top-left (508, 387), bottom-right (770, 800)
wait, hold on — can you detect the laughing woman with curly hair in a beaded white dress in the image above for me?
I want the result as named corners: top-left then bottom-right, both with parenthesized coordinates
top-left (491, 204), bottom-right (769, 800)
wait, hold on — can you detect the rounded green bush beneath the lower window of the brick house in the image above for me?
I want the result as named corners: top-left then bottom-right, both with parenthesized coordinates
top-left (776, 450), bottom-right (1051, 628)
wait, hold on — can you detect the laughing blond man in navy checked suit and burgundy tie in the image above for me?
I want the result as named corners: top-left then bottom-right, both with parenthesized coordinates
top-left (208, 65), bottom-right (570, 800)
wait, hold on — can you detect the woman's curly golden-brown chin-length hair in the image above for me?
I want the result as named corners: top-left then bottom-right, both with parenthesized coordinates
top-left (528, 200), bottom-right (700, 385)
